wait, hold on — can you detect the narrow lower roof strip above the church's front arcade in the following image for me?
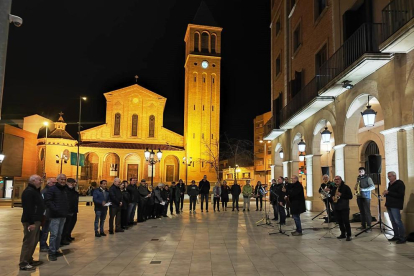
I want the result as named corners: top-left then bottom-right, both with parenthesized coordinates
top-left (80, 142), bottom-right (184, 151)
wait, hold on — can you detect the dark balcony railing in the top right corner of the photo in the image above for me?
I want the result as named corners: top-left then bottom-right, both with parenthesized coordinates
top-left (381, 0), bottom-right (414, 42)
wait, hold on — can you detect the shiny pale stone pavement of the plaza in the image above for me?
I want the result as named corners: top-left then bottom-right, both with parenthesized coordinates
top-left (0, 202), bottom-right (414, 276)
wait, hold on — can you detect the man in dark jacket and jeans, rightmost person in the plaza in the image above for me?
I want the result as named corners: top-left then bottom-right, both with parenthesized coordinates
top-left (383, 171), bottom-right (407, 244)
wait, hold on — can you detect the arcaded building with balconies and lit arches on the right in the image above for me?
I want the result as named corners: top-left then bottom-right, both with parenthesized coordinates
top-left (263, 0), bottom-right (414, 232)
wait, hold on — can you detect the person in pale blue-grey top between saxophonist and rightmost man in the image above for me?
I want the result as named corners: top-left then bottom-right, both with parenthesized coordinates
top-left (354, 167), bottom-right (375, 232)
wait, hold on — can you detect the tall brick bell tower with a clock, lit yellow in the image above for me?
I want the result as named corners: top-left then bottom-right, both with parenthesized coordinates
top-left (184, 2), bottom-right (222, 181)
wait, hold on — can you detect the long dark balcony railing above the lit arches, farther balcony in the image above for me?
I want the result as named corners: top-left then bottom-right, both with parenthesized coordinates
top-left (280, 24), bottom-right (381, 124)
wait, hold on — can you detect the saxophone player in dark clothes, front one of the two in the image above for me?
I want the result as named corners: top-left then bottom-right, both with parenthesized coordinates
top-left (328, 175), bottom-right (352, 241)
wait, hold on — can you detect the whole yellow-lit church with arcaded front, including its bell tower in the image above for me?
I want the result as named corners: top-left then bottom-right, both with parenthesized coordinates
top-left (37, 5), bottom-right (222, 190)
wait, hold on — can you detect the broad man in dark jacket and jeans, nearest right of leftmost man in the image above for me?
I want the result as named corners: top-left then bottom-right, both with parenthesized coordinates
top-left (45, 174), bottom-right (69, 261)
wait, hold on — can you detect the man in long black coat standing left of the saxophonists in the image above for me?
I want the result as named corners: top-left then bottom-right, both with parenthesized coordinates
top-left (282, 175), bottom-right (306, 236)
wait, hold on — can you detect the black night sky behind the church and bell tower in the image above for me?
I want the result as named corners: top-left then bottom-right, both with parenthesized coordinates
top-left (2, 0), bottom-right (270, 140)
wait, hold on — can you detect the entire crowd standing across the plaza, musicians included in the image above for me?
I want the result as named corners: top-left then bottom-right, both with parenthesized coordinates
top-left (19, 167), bottom-right (406, 271)
